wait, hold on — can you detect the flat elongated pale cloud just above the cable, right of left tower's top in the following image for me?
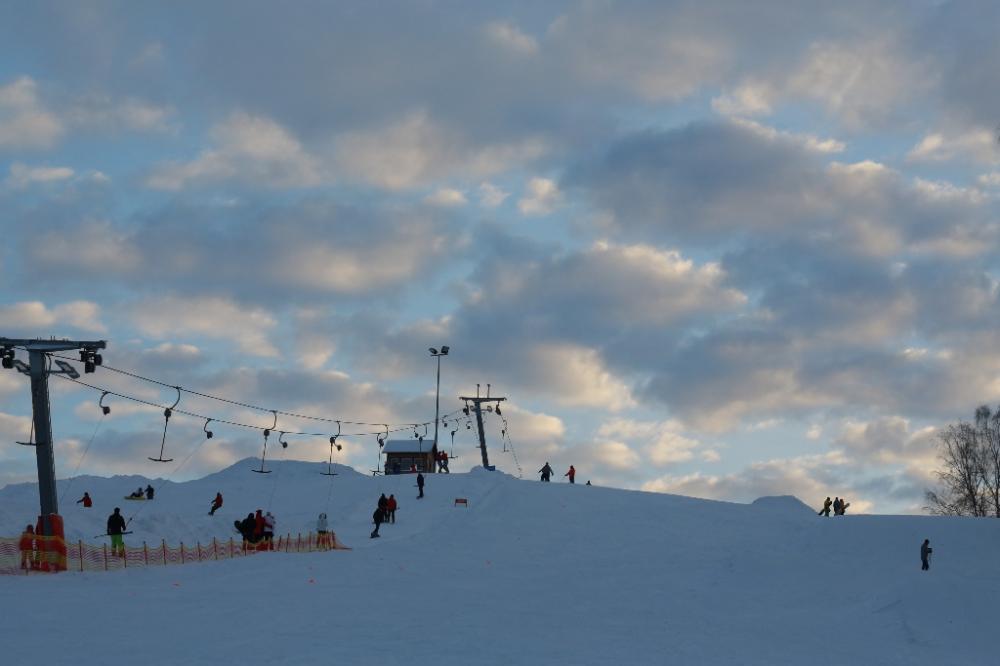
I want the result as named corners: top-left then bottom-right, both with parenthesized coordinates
top-left (132, 296), bottom-right (279, 357)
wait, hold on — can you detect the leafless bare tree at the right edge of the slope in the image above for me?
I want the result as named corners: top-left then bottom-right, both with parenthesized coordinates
top-left (925, 405), bottom-right (1000, 517)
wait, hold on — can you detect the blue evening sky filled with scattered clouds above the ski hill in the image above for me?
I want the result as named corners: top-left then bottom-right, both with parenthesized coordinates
top-left (0, 1), bottom-right (1000, 512)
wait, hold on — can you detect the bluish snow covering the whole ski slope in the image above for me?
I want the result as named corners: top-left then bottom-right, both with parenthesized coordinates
top-left (0, 459), bottom-right (1000, 666)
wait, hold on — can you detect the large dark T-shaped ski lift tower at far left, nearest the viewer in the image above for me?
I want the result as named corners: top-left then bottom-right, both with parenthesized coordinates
top-left (0, 337), bottom-right (107, 564)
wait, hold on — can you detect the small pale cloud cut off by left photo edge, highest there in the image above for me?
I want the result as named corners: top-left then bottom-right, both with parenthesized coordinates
top-left (0, 76), bottom-right (64, 150)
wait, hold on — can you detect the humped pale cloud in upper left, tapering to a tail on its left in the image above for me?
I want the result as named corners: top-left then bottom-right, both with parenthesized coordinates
top-left (146, 112), bottom-right (326, 190)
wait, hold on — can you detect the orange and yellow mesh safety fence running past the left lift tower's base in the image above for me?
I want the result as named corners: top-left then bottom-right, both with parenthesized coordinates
top-left (0, 532), bottom-right (350, 574)
